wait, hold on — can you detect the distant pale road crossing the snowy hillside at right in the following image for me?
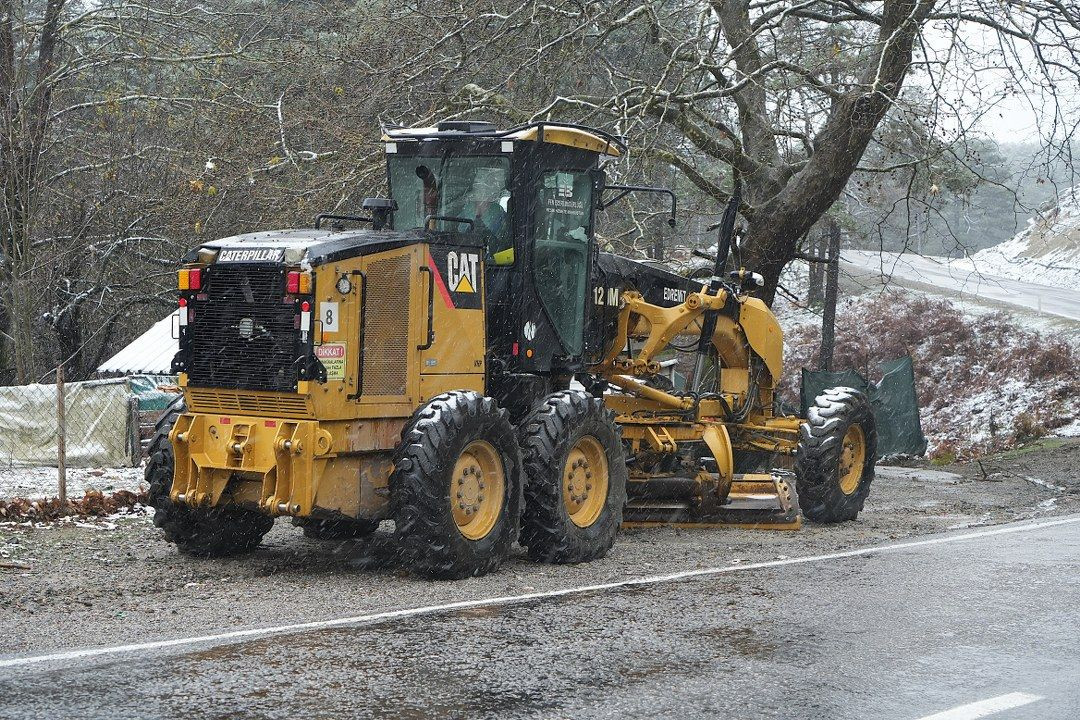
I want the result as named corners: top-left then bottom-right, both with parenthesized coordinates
top-left (841, 250), bottom-right (1080, 321)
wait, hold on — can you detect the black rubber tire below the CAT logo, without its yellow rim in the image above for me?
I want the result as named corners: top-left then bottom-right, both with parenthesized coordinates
top-left (390, 391), bottom-right (522, 580)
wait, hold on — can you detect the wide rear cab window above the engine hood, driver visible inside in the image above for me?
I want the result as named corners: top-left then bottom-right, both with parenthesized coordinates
top-left (389, 154), bottom-right (514, 264)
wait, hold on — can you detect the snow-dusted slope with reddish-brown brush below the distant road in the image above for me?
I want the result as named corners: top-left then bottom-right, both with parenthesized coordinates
top-left (774, 273), bottom-right (1080, 454)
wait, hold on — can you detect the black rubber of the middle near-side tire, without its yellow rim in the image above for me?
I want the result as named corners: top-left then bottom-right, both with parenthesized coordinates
top-left (518, 390), bottom-right (629, 562)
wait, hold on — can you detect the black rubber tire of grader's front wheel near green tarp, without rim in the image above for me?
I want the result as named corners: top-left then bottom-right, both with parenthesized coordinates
top-left (795, 388), bottom-right (877, 522)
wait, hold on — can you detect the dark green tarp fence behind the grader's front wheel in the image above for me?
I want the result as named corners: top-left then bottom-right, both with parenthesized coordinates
top-left (799, 356), bottom-right (927, 458)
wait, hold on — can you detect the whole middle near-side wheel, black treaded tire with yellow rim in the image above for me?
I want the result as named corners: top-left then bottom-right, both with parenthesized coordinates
top-left (518, 390), bottom-right (627, 562)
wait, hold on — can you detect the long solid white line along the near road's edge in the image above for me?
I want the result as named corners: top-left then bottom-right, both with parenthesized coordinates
top-left (0, 515), bottom-right (1080, 668)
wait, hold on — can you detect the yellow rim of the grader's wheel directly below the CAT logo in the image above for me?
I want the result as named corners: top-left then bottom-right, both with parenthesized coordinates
top-left (450, 440), bottom-right (507, 540)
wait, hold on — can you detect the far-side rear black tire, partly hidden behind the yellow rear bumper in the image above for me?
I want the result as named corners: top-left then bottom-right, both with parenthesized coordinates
top-left (146, 397), bottom-right (273, 557)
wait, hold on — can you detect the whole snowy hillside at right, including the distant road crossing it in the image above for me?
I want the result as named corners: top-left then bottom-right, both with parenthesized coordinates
top-left (774, 186), bottom-right (1080, 458)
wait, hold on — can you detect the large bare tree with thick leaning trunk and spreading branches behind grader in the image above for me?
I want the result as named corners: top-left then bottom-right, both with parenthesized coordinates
top-left (369, 0), bottom-right (1080, 300)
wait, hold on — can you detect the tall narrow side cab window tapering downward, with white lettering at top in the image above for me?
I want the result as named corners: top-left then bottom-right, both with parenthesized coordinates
top-left (532, 171), bottom-right (593, 355)
